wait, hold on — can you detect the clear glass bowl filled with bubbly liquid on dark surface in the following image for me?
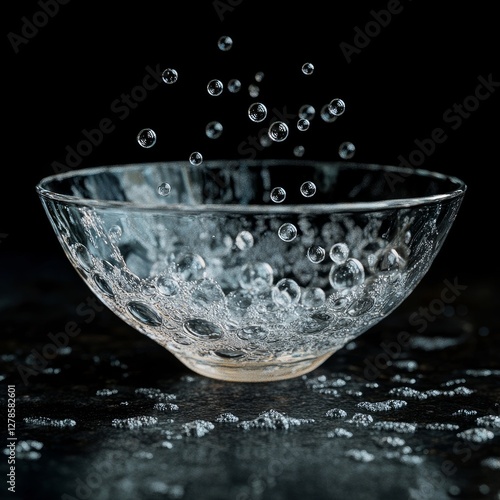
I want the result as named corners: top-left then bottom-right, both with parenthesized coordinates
top-left (37, 160), bottom-right (466, 382)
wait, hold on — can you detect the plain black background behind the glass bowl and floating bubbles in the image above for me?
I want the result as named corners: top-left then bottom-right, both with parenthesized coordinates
top-left (0, 0), bottom-right (500, 308)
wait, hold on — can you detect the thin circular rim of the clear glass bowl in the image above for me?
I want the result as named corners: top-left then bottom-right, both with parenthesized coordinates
top-left (35, 158), bottom-right (467, 214)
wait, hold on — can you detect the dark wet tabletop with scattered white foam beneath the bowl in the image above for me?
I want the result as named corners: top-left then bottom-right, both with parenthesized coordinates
top-left (0, 256), bottom-right (500, 500)
